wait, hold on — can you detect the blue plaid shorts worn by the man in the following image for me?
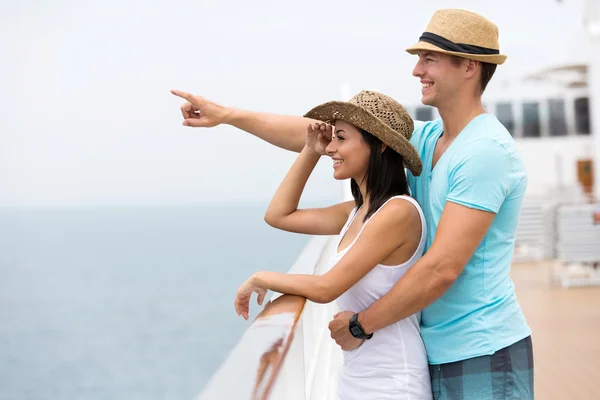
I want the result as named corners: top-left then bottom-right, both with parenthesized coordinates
top-left (429, 336), bottom-right (533, 400)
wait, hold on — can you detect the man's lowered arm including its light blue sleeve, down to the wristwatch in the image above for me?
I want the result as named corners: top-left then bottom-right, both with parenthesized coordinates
top-left (359, 138), bottom-right (524, 332)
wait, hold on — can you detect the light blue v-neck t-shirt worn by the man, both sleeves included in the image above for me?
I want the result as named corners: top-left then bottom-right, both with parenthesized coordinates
top-left (407, 114), bottom-right (531, 364)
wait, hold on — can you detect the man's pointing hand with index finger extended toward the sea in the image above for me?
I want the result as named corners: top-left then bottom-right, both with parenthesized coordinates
top-left (171, 90), bottom-right (231, 128)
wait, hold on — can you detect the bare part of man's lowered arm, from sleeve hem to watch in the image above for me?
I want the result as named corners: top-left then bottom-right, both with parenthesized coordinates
top-left (358, 202), bottom-right (496, 333)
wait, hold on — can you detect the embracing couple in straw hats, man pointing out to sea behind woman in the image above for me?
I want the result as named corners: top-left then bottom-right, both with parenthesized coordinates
top-left (173, 9), bottom-right (533, 400)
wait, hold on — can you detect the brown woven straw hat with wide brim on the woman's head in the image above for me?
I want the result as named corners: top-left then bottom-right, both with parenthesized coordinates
top-left (304, 90), bottom-right (423, 176)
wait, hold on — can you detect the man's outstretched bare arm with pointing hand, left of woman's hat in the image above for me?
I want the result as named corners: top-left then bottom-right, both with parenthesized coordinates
top-left (171, 90), bottom-right (320, 153)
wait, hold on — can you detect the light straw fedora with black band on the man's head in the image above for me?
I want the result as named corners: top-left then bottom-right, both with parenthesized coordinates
top-left (406, 9), bottom-right (506, 64)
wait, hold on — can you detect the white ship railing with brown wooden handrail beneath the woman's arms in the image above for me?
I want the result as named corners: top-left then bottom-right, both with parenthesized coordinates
top-left (195, 236), bottom-right (342, 400)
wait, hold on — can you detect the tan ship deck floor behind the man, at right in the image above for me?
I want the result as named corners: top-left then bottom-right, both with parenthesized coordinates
top-left (511, 263), bottom-right (600, 400)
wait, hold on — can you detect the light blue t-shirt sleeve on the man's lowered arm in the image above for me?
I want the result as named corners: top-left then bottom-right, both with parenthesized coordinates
top-left (448, 138), bottom-right (522, 213)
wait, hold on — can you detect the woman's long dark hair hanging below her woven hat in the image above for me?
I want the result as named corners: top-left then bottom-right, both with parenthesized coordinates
top-left (350, 127), bottom-right (408, 222)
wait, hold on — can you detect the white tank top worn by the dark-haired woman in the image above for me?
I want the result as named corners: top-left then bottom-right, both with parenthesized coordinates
top-left (330, 196), bottom-right (432, 400)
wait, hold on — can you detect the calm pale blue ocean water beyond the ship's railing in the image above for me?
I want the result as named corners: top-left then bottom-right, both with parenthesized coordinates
top-left (0, 204), bottom-right (309, 400)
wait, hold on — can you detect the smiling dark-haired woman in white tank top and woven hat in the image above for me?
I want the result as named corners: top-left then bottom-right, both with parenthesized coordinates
top-left (235, 91), bottom-right (431, 400)
